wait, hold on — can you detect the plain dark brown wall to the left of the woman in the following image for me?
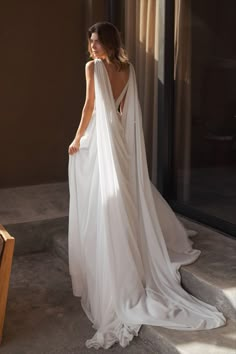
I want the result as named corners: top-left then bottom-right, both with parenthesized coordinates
top-left (0, 0), bottom-right (108, 188)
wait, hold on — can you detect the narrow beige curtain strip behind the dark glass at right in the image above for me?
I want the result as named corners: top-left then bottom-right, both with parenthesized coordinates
top-left (174, 0), bottom-right (192, 202)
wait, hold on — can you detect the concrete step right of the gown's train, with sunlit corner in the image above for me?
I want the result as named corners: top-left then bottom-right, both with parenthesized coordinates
top-left (180, 217), bottom-right (236, 321)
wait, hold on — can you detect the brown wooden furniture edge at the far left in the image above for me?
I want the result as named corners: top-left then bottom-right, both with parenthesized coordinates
top-left (0, 224), bottom-right (15, 343)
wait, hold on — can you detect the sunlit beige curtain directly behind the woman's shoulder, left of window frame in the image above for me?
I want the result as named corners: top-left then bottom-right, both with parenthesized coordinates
top-left (124, 0), bottom-right (158, 183)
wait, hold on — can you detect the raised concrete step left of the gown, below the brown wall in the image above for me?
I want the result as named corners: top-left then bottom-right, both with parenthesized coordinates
top-left (0, 182), bottom-right (69, 255)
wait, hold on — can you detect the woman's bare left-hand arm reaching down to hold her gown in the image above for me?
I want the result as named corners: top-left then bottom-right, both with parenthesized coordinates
top-left (68, 61), bottom-right (95, 154)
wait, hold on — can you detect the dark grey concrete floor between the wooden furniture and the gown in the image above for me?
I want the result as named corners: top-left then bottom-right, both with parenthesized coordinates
top-left (0, 252), bottom-right (157, 354)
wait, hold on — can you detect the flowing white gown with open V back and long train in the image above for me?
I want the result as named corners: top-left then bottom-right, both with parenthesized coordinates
top-left (69, 59), bottom-right (225, 349)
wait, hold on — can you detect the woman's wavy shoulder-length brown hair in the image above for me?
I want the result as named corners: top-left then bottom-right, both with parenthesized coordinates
top-left (88, 22), bottom-right (128, 70)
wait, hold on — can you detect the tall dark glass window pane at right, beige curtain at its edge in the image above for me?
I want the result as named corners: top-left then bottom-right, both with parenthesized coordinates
top-left (173, 0), bottom-right (236, 224)
